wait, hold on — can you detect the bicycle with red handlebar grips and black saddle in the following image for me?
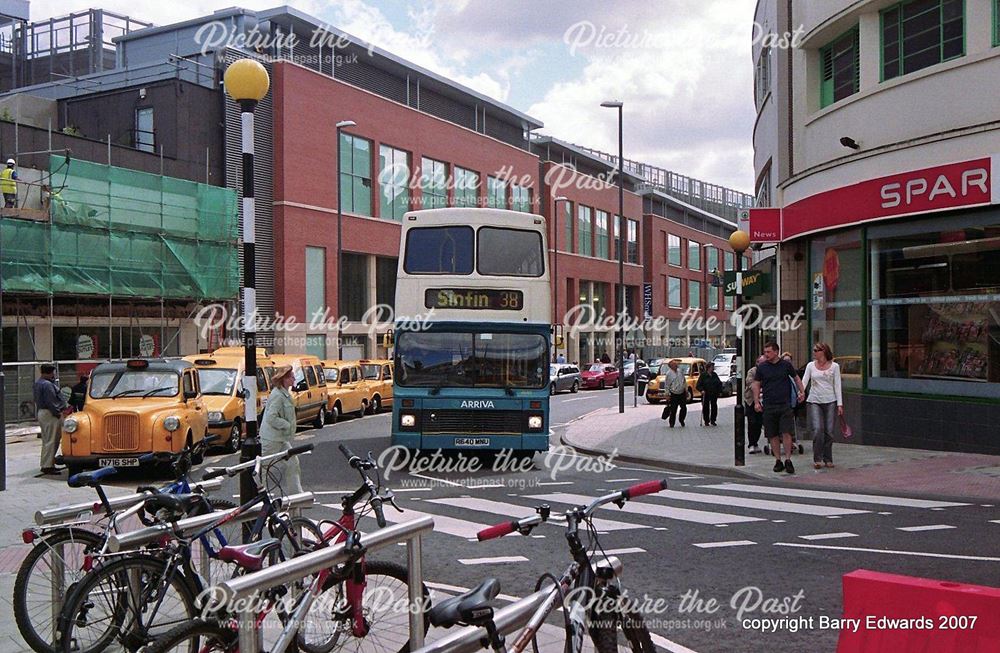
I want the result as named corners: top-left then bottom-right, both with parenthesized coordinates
top-left (427, 481), bottom-right (667, 653)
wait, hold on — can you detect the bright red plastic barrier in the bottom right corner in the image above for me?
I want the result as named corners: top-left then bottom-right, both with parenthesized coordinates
top-left (837, 569), bottom-right (1000, 653)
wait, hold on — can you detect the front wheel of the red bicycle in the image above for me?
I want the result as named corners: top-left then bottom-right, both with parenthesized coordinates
top-left (295, 560), bottom-right (429, 653)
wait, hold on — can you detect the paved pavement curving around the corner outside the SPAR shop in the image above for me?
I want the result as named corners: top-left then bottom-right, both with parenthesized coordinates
top-left (562, 398), bottom-right (1000, 500)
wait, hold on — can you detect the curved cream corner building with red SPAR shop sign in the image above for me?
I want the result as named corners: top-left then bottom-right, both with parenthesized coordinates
top-left (754, 0), bottom-right (1000, 454)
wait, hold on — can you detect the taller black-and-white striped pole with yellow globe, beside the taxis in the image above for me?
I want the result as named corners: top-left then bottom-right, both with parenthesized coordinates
top-left (223, 59), bottom-right (271, 516)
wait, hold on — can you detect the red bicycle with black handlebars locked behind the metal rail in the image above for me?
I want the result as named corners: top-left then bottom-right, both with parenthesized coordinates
top-left (137, 444), bottom-right (429, 653)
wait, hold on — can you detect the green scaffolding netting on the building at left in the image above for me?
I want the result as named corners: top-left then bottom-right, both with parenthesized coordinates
top-left (0, 156), bottom-right (239, 299)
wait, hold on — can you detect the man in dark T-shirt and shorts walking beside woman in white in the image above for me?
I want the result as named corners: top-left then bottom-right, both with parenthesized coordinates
top-left (753, 342), bottom-right (805, 474)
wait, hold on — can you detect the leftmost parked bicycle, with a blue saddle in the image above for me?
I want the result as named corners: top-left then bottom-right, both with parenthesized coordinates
top-left (13, 436), bottom-right (236, 653)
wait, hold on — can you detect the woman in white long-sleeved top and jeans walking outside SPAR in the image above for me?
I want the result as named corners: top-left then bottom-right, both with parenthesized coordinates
top-left (802, 342), bottom-right (844, 469)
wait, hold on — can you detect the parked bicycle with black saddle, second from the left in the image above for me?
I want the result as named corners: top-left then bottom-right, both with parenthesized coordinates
top-left (57, 444), bottom-right (321, 653)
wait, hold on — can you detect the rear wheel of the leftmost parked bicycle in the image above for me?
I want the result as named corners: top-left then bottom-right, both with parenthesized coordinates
top-left (13, 527), bottom-right (103, 653)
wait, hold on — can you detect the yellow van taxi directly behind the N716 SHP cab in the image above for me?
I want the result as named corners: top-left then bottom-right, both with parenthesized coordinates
top-left (184, 347), bottom-right (272, 453)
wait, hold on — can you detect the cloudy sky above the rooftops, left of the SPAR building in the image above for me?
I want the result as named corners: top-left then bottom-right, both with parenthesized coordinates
top-left (31, 0), bottom-right (755, 192)
